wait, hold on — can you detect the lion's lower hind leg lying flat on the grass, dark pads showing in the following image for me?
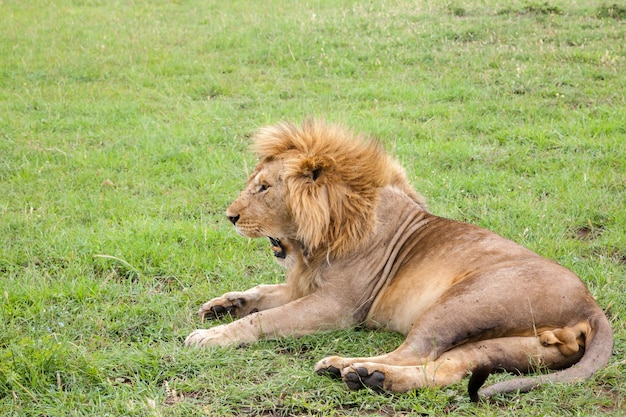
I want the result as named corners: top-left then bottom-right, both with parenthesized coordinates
top-left (330, 329), bottom-right (582, 392)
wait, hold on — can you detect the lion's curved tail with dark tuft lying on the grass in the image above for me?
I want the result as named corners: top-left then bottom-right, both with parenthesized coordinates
top-left (468, 308), bottom-right (613, 401)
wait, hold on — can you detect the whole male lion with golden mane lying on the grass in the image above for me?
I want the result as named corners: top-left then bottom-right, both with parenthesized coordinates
top-left (185, 120), bottom-right (613, 400)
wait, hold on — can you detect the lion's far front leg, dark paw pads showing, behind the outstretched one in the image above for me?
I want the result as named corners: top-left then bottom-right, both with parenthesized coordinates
top-left (198, 284), bottom-right (293, 320)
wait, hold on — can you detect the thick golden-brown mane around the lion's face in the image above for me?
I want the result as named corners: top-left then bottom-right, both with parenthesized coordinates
top-left (252, 119), bottom-right (394, 257)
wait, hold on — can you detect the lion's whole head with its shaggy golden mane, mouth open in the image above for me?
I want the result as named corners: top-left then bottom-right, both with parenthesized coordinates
top-left (226, 120), bottom-right (424, 257)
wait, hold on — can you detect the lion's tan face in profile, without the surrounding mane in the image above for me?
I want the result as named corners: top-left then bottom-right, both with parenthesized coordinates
top-left (226, 159), bottom-right (295, 240)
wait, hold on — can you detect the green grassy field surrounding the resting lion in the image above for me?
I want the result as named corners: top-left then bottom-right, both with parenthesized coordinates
top-left (0, 0), bottom-right (626, 416)
